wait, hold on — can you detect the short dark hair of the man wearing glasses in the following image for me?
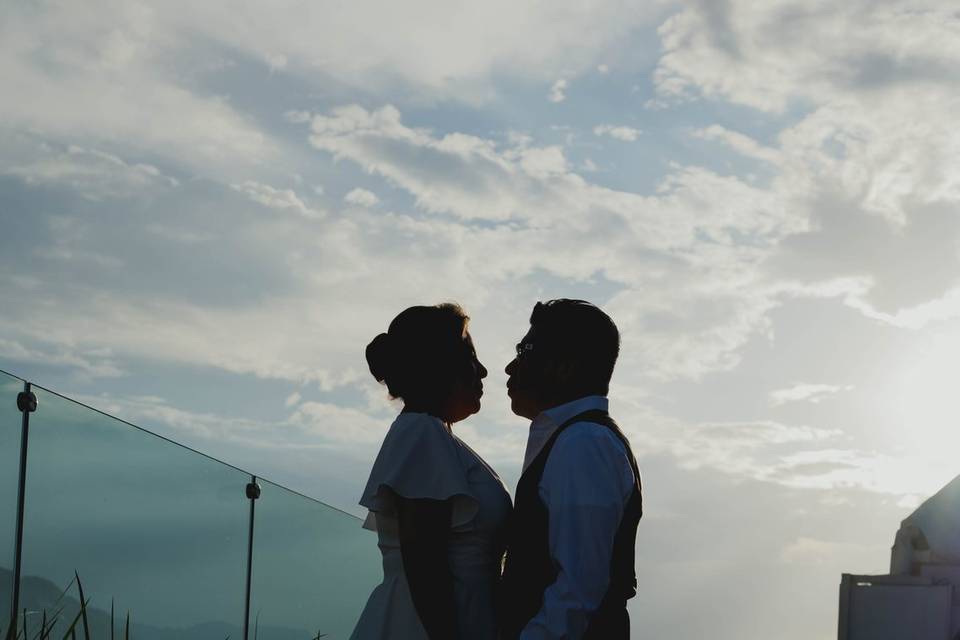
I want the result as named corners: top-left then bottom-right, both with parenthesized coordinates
top-left (530, 298), bottom-right (620, 396)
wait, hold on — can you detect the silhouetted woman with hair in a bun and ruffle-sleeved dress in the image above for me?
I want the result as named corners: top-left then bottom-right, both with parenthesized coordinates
top-left (351, 304), bottom-right (511, 640)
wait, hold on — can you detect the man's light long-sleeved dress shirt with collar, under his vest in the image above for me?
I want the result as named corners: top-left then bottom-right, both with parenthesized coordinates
top-left (520, 396), bottom-right (634, 640)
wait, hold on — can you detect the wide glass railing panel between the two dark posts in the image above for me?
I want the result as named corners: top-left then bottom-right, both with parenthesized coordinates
top-left (20, 387), bottom-right (250, 640)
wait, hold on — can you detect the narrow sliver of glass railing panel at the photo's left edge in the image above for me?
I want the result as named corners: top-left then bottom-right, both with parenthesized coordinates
top-left (0, 372), bottom-right (23, 638)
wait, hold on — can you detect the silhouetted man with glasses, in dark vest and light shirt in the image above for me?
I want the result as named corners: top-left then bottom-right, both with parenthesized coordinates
top-left (500, 299), bottom-right (642, 640)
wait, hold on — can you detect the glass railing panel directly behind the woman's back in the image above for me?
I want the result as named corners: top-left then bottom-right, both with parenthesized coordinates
top-left (250, 480), bottom-right (382, 640)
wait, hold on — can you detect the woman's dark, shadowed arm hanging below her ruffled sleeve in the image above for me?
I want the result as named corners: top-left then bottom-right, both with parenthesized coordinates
top-left (397, 496), bottom-right (457, 640)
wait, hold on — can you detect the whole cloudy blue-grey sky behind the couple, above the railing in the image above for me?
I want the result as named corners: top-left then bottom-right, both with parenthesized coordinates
top-left (0, 0), bottom-right (960, 640)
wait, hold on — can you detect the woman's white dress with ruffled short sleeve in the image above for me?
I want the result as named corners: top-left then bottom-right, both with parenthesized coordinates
top-left (350, 413), bottom-right (511, 640)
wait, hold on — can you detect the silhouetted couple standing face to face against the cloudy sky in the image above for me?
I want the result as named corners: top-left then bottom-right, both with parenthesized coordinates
top-left (351, 299), bottom-right (642, 640)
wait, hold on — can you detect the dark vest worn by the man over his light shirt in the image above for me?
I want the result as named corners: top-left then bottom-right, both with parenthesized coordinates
top-left (498, 410), bottom-right (643, 640)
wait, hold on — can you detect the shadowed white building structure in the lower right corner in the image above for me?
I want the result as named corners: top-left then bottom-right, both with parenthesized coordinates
top-left (837, 476), bottom-right (960, 640)
